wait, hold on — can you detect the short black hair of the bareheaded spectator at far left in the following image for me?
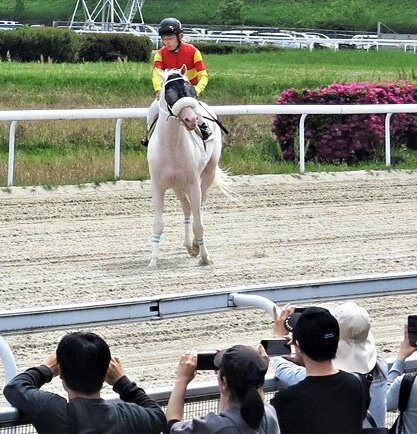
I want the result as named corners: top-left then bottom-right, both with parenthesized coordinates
top-left (56, 332), bottom-right (111, 395)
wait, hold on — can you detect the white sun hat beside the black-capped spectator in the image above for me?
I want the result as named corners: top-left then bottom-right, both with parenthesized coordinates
top-left (332, 302), bottom-right (377, 374)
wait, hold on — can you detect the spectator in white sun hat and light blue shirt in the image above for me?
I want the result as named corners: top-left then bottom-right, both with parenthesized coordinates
top-left (272, 302), bottom-right (388, 428)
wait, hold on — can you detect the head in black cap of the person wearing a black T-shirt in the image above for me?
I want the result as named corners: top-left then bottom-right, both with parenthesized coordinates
top-left (293, 307), bottom-right (340, 362)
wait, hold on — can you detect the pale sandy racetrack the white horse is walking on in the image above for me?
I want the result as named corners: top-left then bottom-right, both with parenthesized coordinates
top-left (0, 171), bottom-right (417, 396)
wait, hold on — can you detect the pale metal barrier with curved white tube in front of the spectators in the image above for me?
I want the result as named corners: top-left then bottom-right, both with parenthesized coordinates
top-left (0, 273), bottom-right (417, 381)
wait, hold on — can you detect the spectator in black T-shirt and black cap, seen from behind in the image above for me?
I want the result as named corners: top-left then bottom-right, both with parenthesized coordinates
top-left (271, 307), bottom-right (366, 434)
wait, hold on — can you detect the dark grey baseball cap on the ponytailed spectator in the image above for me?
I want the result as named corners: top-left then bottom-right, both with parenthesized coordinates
top-left (214, 345), bottom-right (268, 389)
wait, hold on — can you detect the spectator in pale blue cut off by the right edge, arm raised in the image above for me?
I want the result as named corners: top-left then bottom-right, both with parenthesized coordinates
top-left (387, 326), bottom-right (417, 434)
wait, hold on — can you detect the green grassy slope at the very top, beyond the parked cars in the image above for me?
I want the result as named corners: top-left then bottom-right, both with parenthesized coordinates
top-left (0, 0), bottom-right (417, 33)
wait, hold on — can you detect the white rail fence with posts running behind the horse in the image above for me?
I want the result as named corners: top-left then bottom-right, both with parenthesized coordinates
top-left (0, 104), bottom-right (417, 187)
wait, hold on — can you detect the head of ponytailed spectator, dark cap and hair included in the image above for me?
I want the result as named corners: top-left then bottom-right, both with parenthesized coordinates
top-left (215, 345), bottom-right (268, 429)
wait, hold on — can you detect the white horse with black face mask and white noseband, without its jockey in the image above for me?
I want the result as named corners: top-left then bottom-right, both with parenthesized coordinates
top-left (148, 65), bottom-right (227, 267)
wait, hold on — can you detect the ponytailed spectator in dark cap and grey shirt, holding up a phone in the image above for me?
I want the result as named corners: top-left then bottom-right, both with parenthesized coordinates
top-left (166, 345), bottom-right (280, 434)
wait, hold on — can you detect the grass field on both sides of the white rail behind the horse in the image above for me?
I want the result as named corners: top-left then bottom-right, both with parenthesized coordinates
top-left (0, 50), bottom-right (417, 185)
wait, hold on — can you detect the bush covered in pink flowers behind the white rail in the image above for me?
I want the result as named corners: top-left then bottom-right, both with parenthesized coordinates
top-left (272, 81), bottom-right (417, 163)
